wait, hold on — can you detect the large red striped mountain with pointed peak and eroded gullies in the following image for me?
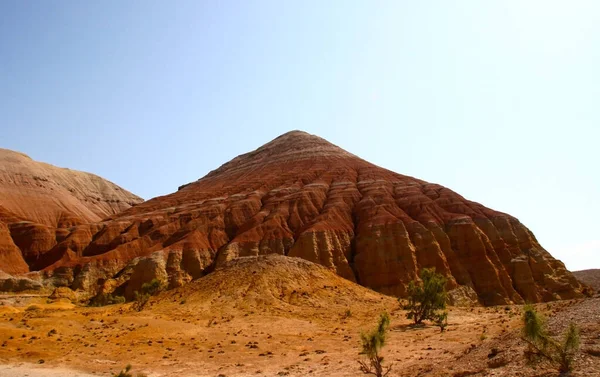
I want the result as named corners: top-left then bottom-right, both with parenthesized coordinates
top-left (0, 131), bottom-right (584, 305)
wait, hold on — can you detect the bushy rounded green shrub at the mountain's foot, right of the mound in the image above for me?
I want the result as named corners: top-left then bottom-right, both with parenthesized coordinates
top-left (403, 268), bottom-right (446, 325)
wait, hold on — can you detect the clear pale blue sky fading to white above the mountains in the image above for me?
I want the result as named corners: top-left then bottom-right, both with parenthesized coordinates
top-left (0, 0), bottom-right (600, 269)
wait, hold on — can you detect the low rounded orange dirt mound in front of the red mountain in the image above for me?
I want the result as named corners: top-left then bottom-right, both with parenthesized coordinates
top-left (156, 254), bottom-right (395, 316)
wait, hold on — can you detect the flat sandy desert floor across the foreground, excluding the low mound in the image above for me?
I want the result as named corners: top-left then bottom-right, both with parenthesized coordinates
top-left (0, 295), bottom-right (600, 377)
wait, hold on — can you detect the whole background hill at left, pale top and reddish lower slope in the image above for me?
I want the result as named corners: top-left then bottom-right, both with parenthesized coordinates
top-left (0, 148), bottom-right (143, 274)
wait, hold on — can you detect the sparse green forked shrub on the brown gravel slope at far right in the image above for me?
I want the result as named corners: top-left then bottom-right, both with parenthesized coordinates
top-left (522, 305), bottom-right (579, 373)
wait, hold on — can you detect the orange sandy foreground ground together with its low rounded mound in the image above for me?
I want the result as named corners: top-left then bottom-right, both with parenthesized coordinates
top-left (0, 254), bottom-right (600, 377)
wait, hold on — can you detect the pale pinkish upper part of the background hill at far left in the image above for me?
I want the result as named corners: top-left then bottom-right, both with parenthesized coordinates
top-left (0, 149), bottom-right (142, 228)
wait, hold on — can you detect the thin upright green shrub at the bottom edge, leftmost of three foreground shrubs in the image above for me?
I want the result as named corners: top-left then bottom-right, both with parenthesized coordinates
top-left (358, 313), bottom-right (392, 377)
